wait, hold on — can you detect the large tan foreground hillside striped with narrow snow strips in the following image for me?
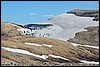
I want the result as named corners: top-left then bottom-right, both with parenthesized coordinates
top-left (1, 36), bottom-right (99, 66)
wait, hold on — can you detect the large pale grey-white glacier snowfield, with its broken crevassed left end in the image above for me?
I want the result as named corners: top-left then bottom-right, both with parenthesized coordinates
top-left (18, 13), bottom-right (99, 41)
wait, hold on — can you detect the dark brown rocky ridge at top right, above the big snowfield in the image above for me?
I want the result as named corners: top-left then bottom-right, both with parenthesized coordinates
top-left (67, 10), bottom-right (99, 21)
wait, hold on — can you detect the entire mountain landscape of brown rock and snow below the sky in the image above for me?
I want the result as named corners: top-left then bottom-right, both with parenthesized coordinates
top-left (1, 10), bottom-right (99, 66)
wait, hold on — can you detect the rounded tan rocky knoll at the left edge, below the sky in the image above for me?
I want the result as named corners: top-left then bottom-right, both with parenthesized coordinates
top-left (1, 22), bottom-right (23, 36)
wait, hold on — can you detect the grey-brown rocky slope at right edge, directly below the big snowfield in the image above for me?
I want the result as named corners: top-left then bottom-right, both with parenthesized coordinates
top-left (68, 26), bottom-right (99, 46)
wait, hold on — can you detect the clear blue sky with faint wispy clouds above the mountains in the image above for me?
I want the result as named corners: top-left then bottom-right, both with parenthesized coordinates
top-left (1, 1), bottom-right (99, 25)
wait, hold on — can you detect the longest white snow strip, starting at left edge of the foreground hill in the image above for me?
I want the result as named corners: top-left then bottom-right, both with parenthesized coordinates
top-left (1, 47), bottom-right (48, 59)
